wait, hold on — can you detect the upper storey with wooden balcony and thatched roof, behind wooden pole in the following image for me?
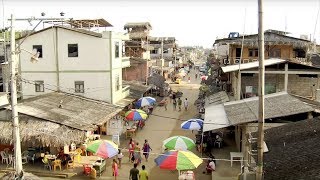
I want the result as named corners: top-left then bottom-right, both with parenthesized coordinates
top-left (214, 30), bottom-right (311, 65)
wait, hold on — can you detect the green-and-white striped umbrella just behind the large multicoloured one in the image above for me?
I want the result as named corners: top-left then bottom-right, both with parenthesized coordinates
top-left (163, 136), bottom-right (196, 150)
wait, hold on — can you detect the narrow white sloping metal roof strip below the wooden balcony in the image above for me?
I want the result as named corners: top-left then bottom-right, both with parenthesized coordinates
top-left (221, 58), bottom-right (286, 73)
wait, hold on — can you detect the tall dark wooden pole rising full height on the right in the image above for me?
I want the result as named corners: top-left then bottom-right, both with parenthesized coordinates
top-left (256, 0), bottom-right (265, 180)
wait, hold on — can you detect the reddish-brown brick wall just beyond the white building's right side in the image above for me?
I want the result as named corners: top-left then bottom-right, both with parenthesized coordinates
top-left (122, 62), bottom-right (148, 82)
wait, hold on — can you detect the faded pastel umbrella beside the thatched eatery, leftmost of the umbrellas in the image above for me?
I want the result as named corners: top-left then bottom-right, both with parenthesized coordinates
top-left (87, 140), bottom-right (118, 159)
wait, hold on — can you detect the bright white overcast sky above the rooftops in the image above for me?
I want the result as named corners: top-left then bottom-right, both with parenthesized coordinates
top-left (0, 0), bottom-right (320, 47)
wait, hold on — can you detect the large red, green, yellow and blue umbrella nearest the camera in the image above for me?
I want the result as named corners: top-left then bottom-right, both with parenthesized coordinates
top-left (154, 151), bottom-right (203, 170)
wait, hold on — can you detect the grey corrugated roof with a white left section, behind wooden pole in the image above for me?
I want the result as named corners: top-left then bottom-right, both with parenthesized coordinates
top-left (203, 92), bottom-right (314, 131)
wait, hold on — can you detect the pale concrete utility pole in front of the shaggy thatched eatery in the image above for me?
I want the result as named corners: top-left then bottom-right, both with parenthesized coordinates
top-left (9, 14), bottom-right (22, 175)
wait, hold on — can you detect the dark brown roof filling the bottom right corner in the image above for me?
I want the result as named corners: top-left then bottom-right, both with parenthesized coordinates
top-left (254, 117), bottom-right (320, 180)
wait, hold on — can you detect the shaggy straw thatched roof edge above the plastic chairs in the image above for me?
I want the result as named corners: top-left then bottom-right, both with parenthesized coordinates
top-left (0, 115), bottom-right (85, 147)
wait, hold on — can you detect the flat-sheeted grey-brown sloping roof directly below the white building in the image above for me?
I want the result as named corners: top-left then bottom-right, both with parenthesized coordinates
top-left (7, 92), bottom-right (122, 131)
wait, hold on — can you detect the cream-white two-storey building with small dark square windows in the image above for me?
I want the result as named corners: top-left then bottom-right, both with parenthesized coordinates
top-left (18, 26), bottom-right (130, 104)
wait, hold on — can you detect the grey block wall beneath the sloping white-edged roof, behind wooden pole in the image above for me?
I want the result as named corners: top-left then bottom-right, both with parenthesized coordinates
top-left (241, 74), bottom-right (320, 97)
